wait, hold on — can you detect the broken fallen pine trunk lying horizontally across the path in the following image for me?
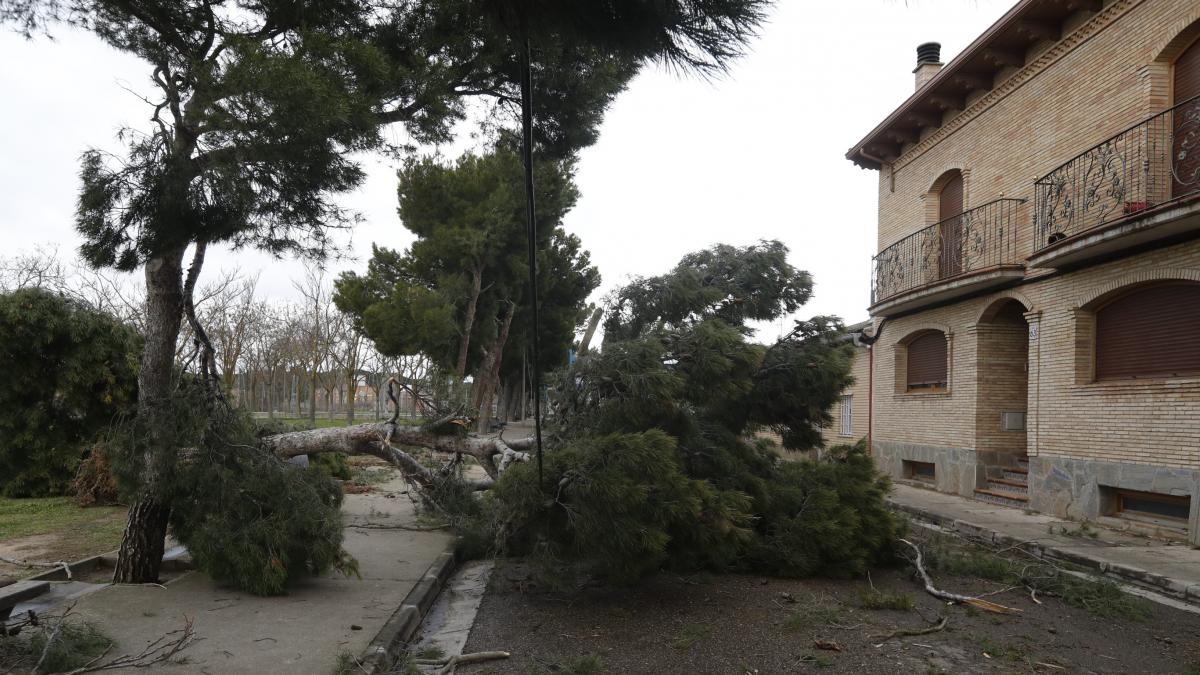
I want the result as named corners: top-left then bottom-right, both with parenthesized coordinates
top-left (262, 420), bottom-right (534, 486)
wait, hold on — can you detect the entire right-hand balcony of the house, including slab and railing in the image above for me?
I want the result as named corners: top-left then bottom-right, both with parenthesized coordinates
top-left (1028, 96), bottom-right (1200, 268)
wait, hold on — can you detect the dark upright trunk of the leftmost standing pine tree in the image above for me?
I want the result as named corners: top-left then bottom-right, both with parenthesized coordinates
top-left (113, 249), bottom-right (184, 584)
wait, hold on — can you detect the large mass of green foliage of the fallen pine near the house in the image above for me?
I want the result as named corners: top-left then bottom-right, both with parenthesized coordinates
top-left (436, 241), bottom-right (899, 583)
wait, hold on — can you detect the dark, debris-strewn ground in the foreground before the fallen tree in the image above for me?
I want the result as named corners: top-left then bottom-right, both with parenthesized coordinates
top-left (460, 562), bottom-right (1200, 675)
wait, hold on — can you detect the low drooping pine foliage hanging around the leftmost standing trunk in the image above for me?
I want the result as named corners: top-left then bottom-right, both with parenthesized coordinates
top-left (104, 386), bottom-right (356, 596)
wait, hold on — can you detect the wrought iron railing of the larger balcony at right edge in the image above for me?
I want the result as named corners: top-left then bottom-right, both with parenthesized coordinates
top-left (1033, 90), bottom-right (1200, 246)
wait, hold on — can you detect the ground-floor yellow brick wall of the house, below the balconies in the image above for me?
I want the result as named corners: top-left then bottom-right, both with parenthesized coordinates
top-left (874, 241), bottom-right (1200, 468)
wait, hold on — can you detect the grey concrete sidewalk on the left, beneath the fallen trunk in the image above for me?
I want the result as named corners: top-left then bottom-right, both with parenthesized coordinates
top-left (76, 473), bottom-right (452, 674)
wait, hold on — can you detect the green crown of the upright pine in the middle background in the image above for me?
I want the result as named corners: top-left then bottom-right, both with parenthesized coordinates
top-left (335, 142), bottom-right (600, 380)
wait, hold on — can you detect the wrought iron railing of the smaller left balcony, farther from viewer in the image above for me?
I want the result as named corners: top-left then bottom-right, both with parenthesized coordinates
top-left (871, 198), bottom-right (1025, 305)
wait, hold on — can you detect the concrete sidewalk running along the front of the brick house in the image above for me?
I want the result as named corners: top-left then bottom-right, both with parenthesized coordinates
top-left (888, 484), bottom-right (1200, 605)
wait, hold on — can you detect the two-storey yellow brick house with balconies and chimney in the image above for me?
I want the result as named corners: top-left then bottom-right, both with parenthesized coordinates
top-left (847, 0), bottom-right (1200, 543)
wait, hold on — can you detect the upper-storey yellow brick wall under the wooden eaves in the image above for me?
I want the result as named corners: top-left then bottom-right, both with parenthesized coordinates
top-left (878, 0), bottom-right (1200, 258)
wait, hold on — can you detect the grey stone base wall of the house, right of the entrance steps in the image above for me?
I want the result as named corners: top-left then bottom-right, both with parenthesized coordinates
top-left (1030, 455), bottom-right (1200, 545)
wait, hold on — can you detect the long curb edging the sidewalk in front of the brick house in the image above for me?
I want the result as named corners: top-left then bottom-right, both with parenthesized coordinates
top-left (888, 500), bottom-right (1200, 607)
